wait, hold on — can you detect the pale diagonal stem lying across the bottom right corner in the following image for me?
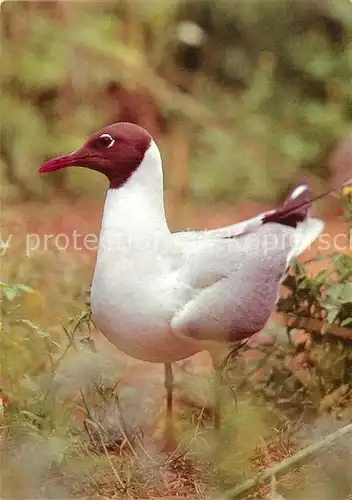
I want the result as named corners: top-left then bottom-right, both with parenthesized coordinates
top-left (219, 424), bottom-right (352, 500)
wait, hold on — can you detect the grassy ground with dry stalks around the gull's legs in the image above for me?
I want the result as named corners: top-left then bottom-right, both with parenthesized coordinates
top-left (0, 197), bottom-right (352, 500)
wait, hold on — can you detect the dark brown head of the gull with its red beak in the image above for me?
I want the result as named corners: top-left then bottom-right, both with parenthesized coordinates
top-left (39, 122), bottom-right (152, 188)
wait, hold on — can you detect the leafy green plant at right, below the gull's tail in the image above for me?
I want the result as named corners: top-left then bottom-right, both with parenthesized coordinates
top-left (256, 200), bottom-right (352, 419)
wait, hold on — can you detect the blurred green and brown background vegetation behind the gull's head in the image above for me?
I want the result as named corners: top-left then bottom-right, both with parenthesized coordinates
top-left (0, 0), bottom-right (352, 201)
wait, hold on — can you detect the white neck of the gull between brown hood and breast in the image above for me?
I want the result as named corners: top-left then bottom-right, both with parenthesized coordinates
top-left (99, 141), bottom-right (169, 251)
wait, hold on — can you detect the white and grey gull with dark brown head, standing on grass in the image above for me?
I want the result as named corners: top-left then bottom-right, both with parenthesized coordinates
top-left (39, 122), bottom-right (324, 450)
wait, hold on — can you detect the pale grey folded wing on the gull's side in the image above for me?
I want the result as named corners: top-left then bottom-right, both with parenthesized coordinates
top-left (171, 224), bottom-right (294, 342)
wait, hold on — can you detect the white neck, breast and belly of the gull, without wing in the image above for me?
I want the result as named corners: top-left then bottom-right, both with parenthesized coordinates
top-left (91, 148), bottom-right (201, 363)
